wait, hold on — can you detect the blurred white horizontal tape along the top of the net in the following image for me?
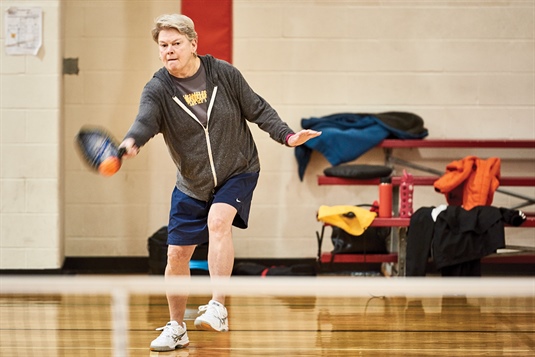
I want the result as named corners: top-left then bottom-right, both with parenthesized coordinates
top-left (0, 275), bottom-right (535, 297)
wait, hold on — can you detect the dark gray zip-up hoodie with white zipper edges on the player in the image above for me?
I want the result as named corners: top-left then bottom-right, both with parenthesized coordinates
top-left (125, 55), bottom-right (293, 201)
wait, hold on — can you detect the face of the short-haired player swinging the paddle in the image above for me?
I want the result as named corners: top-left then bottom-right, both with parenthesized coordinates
top-left (158, 29), bottom-right (197, 78)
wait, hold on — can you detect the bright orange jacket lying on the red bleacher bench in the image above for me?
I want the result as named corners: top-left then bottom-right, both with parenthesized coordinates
top-left (434, 156), bottom-right (501, 210)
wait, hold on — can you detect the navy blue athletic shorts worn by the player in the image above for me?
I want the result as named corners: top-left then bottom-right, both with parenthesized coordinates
top-left (167, 173), bottom-right (259, 245)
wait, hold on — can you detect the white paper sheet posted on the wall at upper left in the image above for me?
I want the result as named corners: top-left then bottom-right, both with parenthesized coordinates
top-left (4, 7), bottom-right (43, 56)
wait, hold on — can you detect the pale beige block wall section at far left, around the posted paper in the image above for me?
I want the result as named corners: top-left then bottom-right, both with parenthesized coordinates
top-left (0, 0), bottom-right (64, 269)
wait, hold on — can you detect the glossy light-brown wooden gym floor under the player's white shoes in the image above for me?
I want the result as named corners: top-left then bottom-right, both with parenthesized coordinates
top-left (0, 295), bottom-right (535, 357)
